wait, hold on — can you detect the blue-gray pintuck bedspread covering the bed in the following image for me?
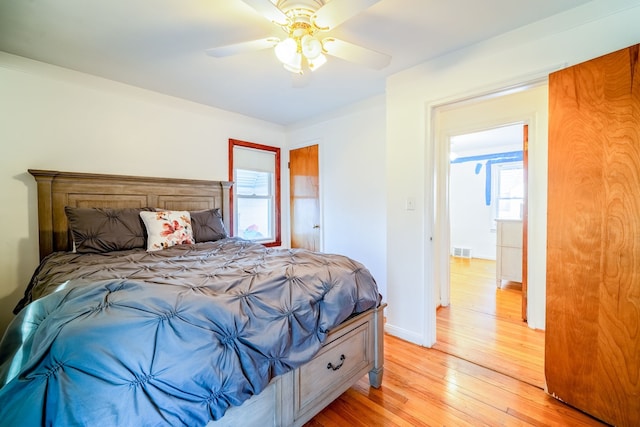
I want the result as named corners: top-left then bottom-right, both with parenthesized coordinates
top-left (0, 238), bottom-right (380, 426)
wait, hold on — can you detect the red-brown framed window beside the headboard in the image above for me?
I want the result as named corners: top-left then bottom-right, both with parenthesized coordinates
top-left (229, 139), bottom-right (281, 246)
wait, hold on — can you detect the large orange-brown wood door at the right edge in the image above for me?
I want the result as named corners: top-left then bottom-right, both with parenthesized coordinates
top-left (545, 45), bottom-right (640, 426)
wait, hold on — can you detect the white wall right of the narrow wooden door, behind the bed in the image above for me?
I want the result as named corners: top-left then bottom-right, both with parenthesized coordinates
top-left (287, 97), bottom-right (387, 300)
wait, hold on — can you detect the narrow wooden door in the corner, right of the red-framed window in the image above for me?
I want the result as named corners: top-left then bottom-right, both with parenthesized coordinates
top-left (289, 144), bottom-right (321, 251)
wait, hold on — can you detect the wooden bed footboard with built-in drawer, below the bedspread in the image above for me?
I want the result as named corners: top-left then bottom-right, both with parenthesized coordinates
top-left (207, 304), bottom-right (386, 427)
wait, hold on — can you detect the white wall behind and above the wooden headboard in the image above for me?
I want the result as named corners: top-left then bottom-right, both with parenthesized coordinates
top-left (0, 53), bottom-right (286, 334)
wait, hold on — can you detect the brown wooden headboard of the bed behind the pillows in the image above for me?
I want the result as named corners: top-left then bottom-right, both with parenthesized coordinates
top-left (29, 169), bottom-right (231, 259)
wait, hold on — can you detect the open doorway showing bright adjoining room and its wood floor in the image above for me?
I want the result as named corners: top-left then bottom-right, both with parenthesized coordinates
top-left (434, 123), bottom-right (544, 387)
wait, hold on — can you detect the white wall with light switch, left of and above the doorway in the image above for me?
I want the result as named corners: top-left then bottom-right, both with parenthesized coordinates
top-left (386, 0), bottom-right (640, 345)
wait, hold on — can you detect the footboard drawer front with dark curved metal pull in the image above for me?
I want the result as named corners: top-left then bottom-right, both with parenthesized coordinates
top-left (294, 322), bottom-right (372, 415)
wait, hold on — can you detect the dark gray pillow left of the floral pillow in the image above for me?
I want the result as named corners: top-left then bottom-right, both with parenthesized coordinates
top-left (64, 206), bottom-right (153, 253)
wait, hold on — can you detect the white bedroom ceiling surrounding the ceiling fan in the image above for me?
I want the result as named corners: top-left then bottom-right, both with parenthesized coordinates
top-left (0, 0), bottom-right (588, 125)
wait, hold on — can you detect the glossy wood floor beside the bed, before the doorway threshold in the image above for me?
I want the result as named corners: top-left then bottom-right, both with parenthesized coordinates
top-left (307, 335), bottom-right (604, 427)
